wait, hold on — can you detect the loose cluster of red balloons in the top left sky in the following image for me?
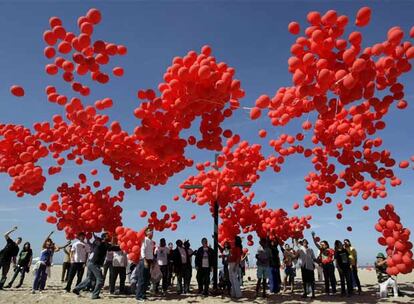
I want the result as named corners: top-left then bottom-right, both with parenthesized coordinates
top-left (43, 8), bottom-right (127, 96)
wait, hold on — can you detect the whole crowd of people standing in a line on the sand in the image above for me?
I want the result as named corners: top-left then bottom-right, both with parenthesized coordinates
top-left (0, 227), bottom-right (399, 302)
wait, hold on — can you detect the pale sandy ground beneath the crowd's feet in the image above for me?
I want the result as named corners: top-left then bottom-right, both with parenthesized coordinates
top-left (0, 265), bottom-right (414, 304)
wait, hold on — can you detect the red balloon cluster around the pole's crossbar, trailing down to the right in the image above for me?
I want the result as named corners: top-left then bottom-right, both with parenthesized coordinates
top-left (181, 140), bottom-right (310, 245)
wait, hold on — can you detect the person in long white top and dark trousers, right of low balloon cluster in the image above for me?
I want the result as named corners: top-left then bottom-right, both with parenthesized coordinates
top-left (136, 227), bottom-right (154, 302)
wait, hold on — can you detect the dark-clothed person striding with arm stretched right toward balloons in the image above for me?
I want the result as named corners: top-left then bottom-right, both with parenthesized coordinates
top-left (72, 233), bottom-right (121, 299)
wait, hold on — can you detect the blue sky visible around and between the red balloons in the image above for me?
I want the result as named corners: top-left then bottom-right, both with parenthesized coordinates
top-left (0, 1), bottom-right (414, 264)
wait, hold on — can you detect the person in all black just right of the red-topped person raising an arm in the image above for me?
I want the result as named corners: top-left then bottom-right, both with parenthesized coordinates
top-left (335, 240), bottom-right (352, 297)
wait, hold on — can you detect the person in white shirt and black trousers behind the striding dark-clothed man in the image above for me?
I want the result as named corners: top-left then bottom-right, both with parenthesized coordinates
top-left (65, 232), bottom-right (89, 292)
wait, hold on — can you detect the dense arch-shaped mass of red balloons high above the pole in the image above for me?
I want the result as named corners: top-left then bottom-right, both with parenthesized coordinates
top-left (134, 45), bottom-right (244, 152)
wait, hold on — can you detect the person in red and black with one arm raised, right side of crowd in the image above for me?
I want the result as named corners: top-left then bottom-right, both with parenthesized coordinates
top-left (312, 232), bottom-right (336, 295)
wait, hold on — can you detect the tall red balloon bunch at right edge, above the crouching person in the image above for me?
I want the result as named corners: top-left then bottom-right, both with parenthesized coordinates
top-left (375, 204), bottom-right (414, 275)
